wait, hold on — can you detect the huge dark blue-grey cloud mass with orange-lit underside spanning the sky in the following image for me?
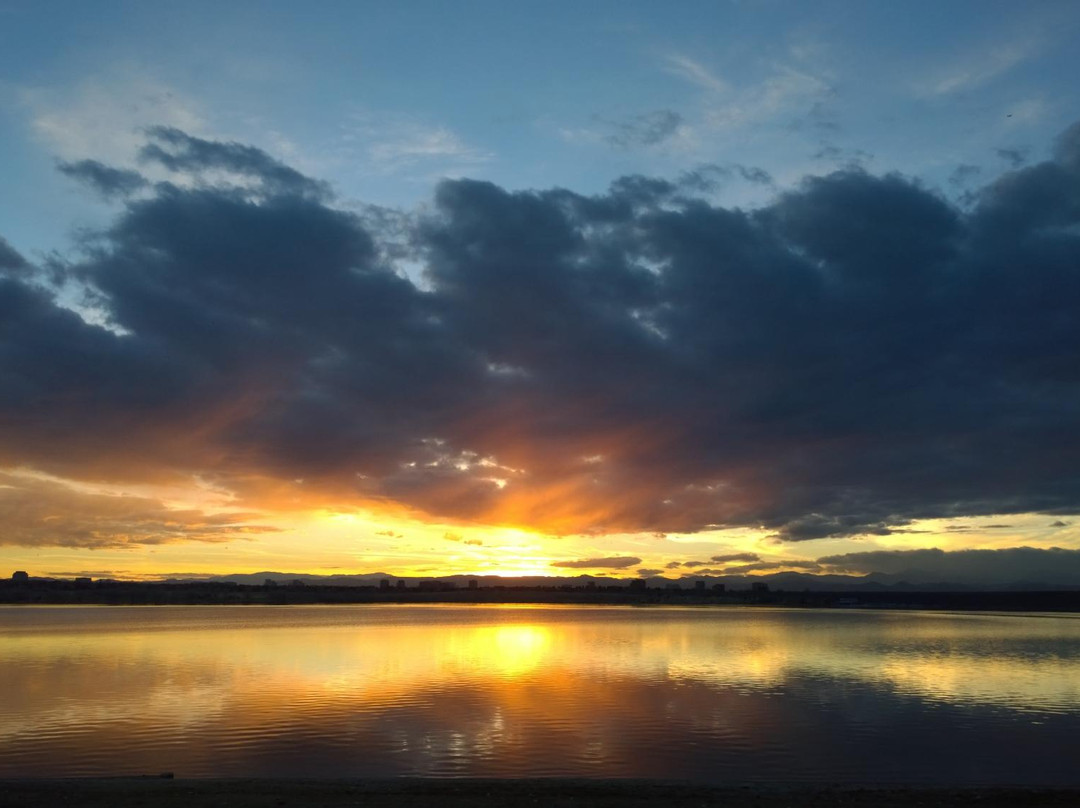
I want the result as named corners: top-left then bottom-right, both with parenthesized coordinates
top-left (0, 119), bottom-right (1080, 563)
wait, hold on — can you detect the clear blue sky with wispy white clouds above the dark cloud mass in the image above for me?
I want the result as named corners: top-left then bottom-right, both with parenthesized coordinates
top-left (6, 0), bottom-right (1080, 259)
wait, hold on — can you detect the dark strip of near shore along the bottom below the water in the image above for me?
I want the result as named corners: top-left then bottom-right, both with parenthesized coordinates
top-left (0, 778), bottom-right (1080, 808)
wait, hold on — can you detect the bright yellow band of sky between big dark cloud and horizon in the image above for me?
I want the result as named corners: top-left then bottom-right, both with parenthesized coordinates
top-left (0, 464), bottom-right (1080, 579)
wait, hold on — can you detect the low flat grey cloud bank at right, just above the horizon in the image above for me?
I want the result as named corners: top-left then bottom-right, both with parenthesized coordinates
top-left (818, 547), bottom-right (1080, 583)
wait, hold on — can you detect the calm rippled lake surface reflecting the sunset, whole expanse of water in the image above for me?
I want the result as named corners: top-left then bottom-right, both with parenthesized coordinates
top-left (0, 606), bottom-right (1080, 785)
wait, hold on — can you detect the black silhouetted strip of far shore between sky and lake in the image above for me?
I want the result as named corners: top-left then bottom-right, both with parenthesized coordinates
top-left (0, 579), bottom-right (1080, 612)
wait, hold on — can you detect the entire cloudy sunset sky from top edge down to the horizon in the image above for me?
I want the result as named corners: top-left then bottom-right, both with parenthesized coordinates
top-left (0, 0), bottom-right (1080, 584)
